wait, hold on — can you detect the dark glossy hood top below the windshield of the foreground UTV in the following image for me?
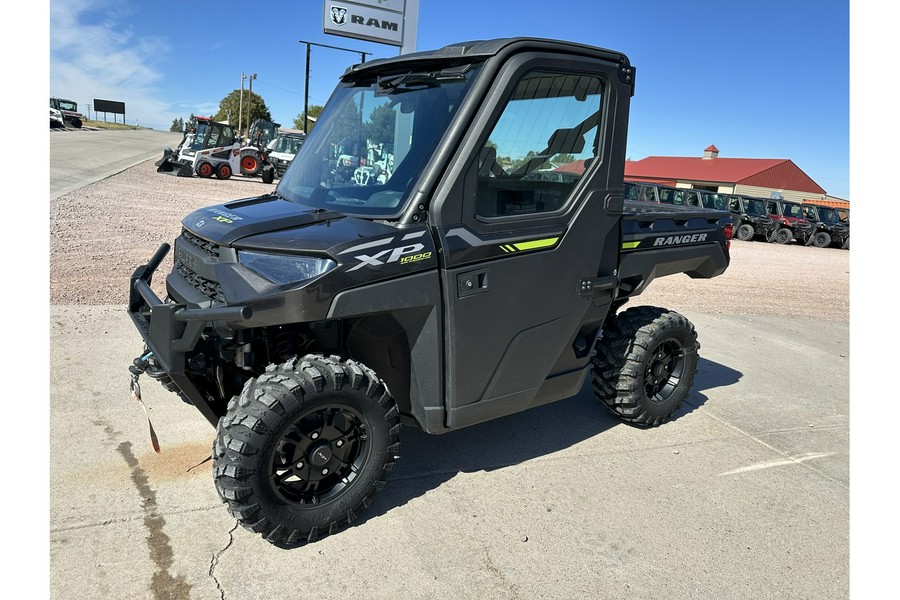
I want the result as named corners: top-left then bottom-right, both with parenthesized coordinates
top-left (181, 195), bottom-right (345, 246)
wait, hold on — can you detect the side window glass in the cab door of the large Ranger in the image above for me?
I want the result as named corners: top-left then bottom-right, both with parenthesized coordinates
top-left (475, 71), bottom-right (603, 217)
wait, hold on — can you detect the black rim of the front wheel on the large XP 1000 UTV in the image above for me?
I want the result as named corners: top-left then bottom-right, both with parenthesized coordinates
top-left (269, 406), bottom-right (370, 505)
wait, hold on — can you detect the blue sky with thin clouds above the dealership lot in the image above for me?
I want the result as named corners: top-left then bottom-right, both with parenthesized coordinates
top-left (49, 0), bottom-right (850, 198)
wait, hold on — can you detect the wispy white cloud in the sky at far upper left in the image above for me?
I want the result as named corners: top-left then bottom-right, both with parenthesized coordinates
top-left (50, 0), bottom-right (177, 129)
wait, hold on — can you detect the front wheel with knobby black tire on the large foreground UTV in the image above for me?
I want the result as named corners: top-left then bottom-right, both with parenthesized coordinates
top-left (213, 355), bottom-right (400, 547)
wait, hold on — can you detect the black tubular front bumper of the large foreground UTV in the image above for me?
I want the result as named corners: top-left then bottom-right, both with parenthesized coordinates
top-left (128, 244), bottom-right (253, 426)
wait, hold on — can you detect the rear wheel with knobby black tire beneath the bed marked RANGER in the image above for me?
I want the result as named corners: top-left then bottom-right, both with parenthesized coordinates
top-left (592, 306), bottom-right (700, 427)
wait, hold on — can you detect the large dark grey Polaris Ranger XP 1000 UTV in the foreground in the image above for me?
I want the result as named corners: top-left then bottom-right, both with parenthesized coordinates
top-left (128, 38), bottom-right (732, 547)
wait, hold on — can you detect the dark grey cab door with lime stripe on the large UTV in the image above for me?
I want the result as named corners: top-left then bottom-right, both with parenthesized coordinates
top-left (435, 54), bottom-right (630, 428)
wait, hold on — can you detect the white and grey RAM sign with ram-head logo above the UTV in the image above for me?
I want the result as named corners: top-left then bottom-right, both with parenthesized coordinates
top-left (322, 0), bottom-right (404, 46)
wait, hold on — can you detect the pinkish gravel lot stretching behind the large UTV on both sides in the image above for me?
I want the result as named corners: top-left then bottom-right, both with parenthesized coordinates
top-left (50, 160), bottom-right (850, 321)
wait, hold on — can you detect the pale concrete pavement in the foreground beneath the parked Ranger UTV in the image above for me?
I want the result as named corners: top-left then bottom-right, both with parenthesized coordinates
top-left (50, 306), bottom-right (849, 600)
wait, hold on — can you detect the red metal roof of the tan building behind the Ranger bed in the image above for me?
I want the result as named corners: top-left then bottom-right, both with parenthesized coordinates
top-left (625, 155), bottom-right (825, 194)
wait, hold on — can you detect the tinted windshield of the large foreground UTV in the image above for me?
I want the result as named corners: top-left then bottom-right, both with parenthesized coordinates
top-left (276, 65), bottom-right (480, 218)
